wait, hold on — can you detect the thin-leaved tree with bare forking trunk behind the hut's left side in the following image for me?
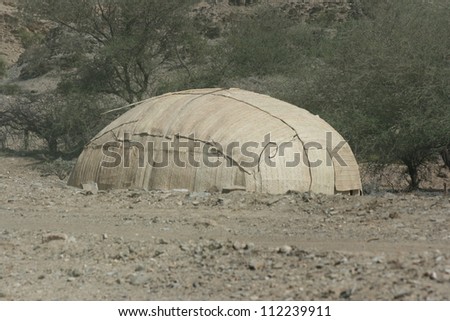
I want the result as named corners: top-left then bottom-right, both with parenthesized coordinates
top-left (21, 0), bottom-right (201, 103)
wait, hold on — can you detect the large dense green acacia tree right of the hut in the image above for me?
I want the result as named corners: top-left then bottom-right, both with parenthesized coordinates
top-left (306, 0), bottom-right (450, 189)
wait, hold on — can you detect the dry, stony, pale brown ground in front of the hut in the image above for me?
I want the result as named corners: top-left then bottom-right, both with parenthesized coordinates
top-left (0, 156), bottom-right (450, 300)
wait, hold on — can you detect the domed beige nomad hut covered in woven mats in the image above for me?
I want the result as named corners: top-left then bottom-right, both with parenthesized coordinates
top-left (68, 88), bottom-right (361, 195)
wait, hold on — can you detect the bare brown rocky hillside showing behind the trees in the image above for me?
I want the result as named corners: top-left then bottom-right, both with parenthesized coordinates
top-left (0, 0), bottom-right (352, 99)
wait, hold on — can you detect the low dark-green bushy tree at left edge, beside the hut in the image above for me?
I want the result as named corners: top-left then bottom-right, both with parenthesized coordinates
top-left (0, 94), bottom-right (107, 158)
